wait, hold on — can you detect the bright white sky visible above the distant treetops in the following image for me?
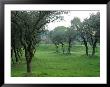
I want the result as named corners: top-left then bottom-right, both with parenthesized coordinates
top-left (47, 11), bottom-right (98, 30)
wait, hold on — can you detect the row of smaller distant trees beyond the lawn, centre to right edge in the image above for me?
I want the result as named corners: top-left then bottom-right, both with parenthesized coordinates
top-left (50, 12), bottom-right (100, 56)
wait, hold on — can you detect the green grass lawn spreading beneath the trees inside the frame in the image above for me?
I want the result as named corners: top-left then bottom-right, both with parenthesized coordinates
top-left (11, 44), bottom-right (100, 77)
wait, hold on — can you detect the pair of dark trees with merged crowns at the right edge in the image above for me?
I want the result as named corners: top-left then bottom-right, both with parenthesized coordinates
top-left (71, 12), bottom-right (100, 55)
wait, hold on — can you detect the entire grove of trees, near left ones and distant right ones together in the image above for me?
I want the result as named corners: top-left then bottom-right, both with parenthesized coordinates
top-left (11, 11), bottom-right (100, 73)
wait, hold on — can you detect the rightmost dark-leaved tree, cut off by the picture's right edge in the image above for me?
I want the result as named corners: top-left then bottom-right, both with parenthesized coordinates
top-left (84, 12), bottom-right (100, 56)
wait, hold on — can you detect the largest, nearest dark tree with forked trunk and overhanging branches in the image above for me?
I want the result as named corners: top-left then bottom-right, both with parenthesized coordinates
top-left (11, 11), bottom-right (67, 73)
